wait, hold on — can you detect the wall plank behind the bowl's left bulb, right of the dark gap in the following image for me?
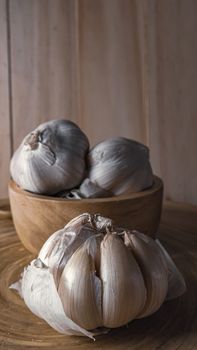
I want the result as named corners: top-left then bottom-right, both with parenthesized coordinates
top-left (10, 0), bottom-right (78, 148)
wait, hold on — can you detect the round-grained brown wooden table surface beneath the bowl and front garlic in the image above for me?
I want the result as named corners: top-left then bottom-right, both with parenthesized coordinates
top-left (0, 200), bottom-right (197, 350)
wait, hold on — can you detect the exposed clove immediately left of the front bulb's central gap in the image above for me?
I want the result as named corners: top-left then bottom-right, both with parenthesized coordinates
top-left (58, 237), bottom-right (102, 329)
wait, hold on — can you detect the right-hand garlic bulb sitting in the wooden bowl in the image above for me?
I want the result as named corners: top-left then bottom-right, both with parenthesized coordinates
top-left (88, 137), bottom-right (153, 195)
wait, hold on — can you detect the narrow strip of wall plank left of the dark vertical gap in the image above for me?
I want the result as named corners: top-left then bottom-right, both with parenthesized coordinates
top-left (0, 0), bottom-right (10, 198)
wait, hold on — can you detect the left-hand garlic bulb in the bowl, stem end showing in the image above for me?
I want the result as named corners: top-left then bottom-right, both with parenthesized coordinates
top-left (10, 120), bottom-right (89, 194)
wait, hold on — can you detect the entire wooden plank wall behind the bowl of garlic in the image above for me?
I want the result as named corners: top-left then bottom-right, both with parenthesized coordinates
top-left (0, 0), bottom-right (197, 203)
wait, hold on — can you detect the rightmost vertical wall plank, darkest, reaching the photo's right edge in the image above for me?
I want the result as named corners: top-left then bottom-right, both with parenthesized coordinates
top-left (148, 0), bottom-right (197, 204)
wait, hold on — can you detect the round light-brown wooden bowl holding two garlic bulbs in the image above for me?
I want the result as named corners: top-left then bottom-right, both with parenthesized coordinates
top-left (9, 176), bottom-right (163, 254)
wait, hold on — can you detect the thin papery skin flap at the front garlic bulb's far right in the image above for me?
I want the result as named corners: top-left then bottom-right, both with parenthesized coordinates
top-left (156, 239), bottom-right (187, 300)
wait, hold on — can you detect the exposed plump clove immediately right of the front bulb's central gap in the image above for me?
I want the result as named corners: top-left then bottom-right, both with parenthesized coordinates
top-left (100, 233), bottom-right (146, 328)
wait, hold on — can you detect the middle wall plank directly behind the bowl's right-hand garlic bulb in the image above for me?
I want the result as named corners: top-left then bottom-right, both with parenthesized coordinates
top-left (78, 0), bottom-right (146, 143)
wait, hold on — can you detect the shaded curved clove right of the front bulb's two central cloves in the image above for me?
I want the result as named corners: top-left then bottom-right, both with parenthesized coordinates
top-left (125, 231), bottom-right (168, 318)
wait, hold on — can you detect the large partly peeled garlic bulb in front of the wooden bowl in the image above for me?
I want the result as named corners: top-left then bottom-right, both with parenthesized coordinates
top-left (11, 213), bottom-right (186, 338)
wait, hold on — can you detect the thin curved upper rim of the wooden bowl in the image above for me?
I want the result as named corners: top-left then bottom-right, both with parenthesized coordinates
top-left (8, 175), bottom-right (163, 204)
